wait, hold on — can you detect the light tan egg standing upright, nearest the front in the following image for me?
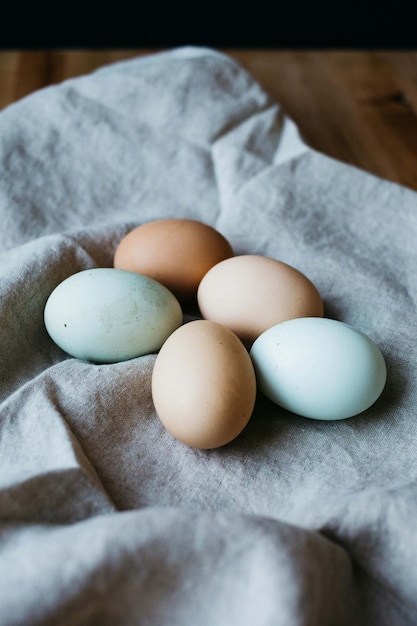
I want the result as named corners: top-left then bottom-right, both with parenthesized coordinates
top-left (152, 320), bottom-right (256, 449)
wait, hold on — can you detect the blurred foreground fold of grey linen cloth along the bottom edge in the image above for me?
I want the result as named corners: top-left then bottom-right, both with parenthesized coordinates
top-left (0, 509), bottom-right (352, 626)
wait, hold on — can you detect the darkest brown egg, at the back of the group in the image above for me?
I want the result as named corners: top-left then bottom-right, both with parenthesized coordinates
top-left (114, 218), bottom-right (233, 302)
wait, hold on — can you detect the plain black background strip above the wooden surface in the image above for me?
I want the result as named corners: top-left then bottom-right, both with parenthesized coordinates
top-left (0, 0), bottom-right (417, 49)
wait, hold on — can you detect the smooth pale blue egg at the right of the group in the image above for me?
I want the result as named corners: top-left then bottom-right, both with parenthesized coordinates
top-left (250, 318), bottom-right (387, 420)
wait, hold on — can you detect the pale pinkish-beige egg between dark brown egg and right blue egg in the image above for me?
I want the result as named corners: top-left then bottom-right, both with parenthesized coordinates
top-left (197, 254), bottom-right (323, 347)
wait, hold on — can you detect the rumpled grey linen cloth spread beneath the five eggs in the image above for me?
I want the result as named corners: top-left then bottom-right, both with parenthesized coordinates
top-left (0, 48), bottom-right (417, 626)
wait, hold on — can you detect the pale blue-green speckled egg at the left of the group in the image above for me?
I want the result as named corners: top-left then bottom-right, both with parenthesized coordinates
top-left (44, 268), bottom-right (183, 363)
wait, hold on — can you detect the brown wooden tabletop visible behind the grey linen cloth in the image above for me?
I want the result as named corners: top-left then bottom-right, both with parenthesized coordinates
top-left (0, 49), bottom-right (417, 190)
